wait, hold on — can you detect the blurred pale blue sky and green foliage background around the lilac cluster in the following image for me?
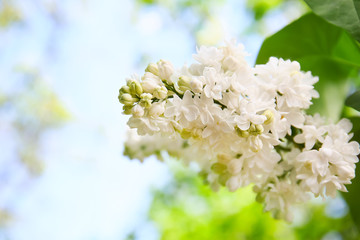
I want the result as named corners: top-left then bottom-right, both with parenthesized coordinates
top-left (0, 0), bottom-right (359, 240)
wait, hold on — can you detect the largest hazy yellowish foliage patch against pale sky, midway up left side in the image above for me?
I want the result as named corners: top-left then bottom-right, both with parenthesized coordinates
top-left (0, 68), bottom-right (70, 175)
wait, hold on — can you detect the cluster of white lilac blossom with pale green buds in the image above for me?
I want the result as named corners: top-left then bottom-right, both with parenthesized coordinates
top-left (119, 42), bottom-right (360, 221)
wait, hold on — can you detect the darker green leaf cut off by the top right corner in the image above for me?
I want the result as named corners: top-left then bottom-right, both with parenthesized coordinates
top-left (305, 0), bottom-right (360, 41)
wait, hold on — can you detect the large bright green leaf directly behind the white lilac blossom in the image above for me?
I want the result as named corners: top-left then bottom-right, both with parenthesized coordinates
top-left (256, 13), bottom-right (360, 120)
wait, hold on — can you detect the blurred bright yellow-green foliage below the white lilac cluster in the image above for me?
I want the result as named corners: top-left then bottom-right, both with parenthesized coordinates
top-left (129, 161), bottom-right (360, 240)
